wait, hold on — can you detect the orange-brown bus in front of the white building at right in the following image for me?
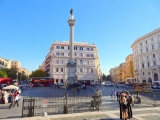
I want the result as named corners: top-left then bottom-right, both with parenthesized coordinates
top-left (134, 82), bottom-right (152, 92)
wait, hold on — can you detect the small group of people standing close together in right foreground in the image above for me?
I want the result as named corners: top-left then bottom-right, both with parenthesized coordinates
top-left (116, 91), bottom-right (133, 120)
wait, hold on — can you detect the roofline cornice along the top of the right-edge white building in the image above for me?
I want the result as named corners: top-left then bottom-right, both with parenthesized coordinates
top-left (130, 28), bottom-right (160, 48)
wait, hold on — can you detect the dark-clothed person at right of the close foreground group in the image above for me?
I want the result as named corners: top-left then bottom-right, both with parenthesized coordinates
top-left (126, 91), bottom-right (133, 119)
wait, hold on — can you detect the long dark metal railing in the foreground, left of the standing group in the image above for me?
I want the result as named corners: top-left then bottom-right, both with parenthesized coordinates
top-left (22, 94), bottom-right (101, 117)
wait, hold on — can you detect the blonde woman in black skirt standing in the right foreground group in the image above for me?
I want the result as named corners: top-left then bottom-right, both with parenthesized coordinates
top-left (121, 93), bottom-right (127, 120)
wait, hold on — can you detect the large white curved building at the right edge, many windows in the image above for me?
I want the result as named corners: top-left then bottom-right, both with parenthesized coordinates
top-left (131, 28), bottom-right (160, 84)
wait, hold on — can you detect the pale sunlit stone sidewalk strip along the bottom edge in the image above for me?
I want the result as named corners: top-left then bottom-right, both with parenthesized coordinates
top-left (5, 107), bottom-right (160, 120)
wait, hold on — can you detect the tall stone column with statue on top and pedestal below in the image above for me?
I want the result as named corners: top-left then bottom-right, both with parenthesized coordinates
top-left (67, 9), bottom-right (77, 84)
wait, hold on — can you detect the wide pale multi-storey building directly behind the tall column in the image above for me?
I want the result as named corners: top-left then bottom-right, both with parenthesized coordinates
top-left (45, 41), bottom-right (101, 82)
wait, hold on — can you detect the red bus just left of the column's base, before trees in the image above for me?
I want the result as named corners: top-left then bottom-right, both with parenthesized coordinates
top-left (30, 77), bottom-right (54, 87)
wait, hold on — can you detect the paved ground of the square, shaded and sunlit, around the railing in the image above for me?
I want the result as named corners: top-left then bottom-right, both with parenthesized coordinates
top-left (0, 86), bottom-right (160, 120)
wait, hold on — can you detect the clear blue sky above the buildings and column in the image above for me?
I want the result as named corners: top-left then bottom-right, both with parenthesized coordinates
top-left (0, 0), bottom-right (160, 74)
